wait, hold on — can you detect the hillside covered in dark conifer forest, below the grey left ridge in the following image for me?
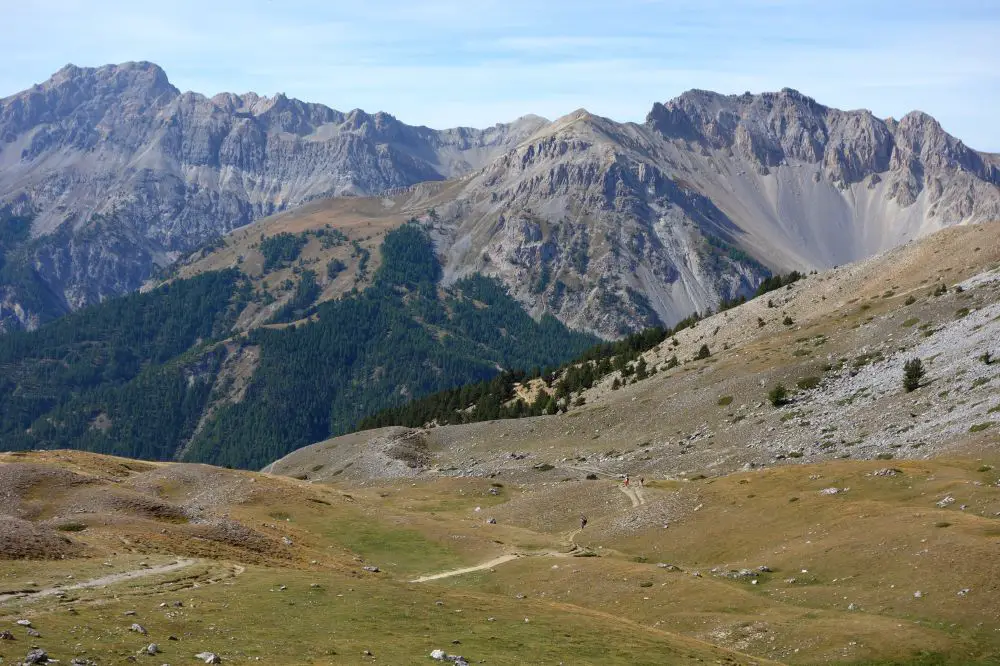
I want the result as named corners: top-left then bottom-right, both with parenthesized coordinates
top-left (0, 223), bottom-right (595, 468)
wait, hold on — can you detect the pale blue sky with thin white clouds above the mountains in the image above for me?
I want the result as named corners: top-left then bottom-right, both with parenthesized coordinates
top-left (0, 0), bottom-right (1000, 152)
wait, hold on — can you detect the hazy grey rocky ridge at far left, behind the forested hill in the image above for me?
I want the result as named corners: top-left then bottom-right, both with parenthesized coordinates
top-left (0, 63), bottom-right (545, 328)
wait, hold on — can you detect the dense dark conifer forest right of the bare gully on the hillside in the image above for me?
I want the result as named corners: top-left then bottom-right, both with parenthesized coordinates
top-left (186, 224), bottom-right (595, 467)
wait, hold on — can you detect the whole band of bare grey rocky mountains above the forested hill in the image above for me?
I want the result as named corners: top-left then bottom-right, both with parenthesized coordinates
top-left (0, 63), bottom-right (1000, 337)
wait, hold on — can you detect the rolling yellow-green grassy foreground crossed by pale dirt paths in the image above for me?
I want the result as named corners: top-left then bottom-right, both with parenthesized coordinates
top-left (0, 440), bottom-right (1000, 666)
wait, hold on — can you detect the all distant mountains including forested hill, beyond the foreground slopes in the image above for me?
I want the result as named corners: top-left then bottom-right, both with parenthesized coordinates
top-left (0, 63), bottom-right (1000, 468)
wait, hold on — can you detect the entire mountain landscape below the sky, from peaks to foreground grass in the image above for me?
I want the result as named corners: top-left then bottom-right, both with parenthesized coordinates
top-left (0, 59), bottom-right (1000, 666)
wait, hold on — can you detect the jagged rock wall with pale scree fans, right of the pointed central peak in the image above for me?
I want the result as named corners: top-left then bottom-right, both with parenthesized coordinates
top-left (644, 89), bottom-right (1000, 268)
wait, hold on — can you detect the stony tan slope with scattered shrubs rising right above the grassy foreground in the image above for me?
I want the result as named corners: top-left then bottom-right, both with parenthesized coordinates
top-left (268, 223), bottom-right (1000, 480)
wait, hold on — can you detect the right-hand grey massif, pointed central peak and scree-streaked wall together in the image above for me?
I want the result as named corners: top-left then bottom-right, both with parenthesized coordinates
top-left (428, 89), bottom-right (1000, 337)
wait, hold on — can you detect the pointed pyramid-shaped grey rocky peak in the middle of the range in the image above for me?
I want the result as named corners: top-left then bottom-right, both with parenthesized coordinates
top-left (437, 111), bottom-right (767, 338)
